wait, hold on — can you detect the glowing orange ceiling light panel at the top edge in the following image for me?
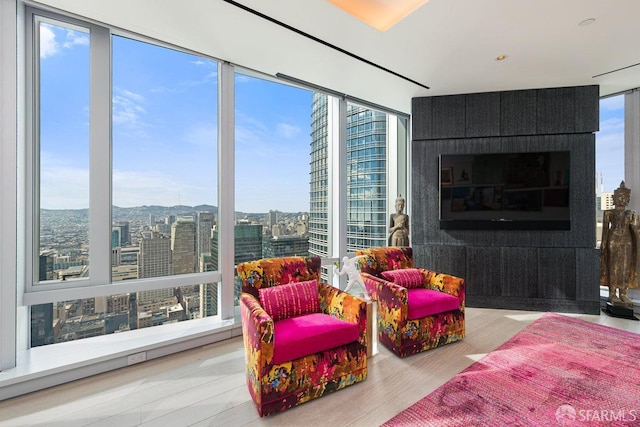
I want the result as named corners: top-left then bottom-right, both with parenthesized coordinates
top-left (327, 0), bottom-right (429, 32)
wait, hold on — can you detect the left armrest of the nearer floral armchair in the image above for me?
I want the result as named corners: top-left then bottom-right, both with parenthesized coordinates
top-left (240, 293), bottom-right (273, 364)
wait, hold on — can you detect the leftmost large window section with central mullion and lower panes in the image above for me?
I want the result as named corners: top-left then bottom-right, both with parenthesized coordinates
top-left (27, 11), bottom-right (218, 347)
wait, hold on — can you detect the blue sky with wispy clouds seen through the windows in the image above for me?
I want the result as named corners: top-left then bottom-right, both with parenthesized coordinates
top-left (40, 21), bottom-right (624, 212)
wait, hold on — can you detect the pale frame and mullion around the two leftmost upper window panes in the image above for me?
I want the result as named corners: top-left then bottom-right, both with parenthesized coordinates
top-left (22, 7), bottom-right (222, 306)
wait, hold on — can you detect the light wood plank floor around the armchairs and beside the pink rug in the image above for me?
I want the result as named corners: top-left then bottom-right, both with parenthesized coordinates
top-left (0, 308), bottom-right (640, 427)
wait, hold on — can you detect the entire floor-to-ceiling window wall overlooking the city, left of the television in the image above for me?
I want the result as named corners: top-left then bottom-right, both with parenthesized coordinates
top-left (1, 1), bottom-right (408, 394)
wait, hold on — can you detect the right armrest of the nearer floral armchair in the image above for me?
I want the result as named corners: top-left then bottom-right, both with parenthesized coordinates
top-left (318, 283), bottom-right (367, 345)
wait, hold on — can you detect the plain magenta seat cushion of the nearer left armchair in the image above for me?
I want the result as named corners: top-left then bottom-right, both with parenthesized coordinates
top-left (273, 313), bottom-right (360, 364)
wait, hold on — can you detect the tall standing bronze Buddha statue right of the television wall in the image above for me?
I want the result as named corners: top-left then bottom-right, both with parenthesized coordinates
top-left (600, 181), bottom-right (639, 307)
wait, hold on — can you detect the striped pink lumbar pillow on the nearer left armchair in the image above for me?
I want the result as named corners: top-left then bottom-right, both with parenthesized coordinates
top-left (259, 279), bottom-right (320, 322)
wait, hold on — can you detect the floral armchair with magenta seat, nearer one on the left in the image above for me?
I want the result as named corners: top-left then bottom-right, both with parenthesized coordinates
top-left (237, 257), bottom-right (367, 416)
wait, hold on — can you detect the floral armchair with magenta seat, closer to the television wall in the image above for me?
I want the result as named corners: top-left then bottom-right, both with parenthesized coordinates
top-left (356, 247), bottom-right (465, 357)
